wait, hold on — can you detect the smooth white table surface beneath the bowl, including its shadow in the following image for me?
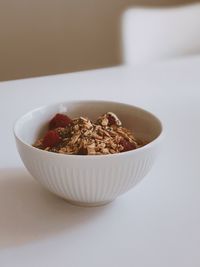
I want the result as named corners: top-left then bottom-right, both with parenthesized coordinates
top-left (0, 56), bottom-right (200, 267)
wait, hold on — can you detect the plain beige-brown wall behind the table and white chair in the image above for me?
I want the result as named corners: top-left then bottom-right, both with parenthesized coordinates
top-left (0, 0), bottom-right (195, 80)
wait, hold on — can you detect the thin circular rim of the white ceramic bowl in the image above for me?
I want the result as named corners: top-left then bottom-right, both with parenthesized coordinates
top-left (13, 100), bottom-right (164, 159)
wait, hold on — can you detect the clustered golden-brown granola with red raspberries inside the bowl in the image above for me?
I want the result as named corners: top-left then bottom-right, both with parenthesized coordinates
top-left (34, 112), bottom-right (144, 155)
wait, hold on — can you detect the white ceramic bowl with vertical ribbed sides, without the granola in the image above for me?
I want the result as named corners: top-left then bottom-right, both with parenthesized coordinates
top-left (14, 101), bottom-right (163, 206)
